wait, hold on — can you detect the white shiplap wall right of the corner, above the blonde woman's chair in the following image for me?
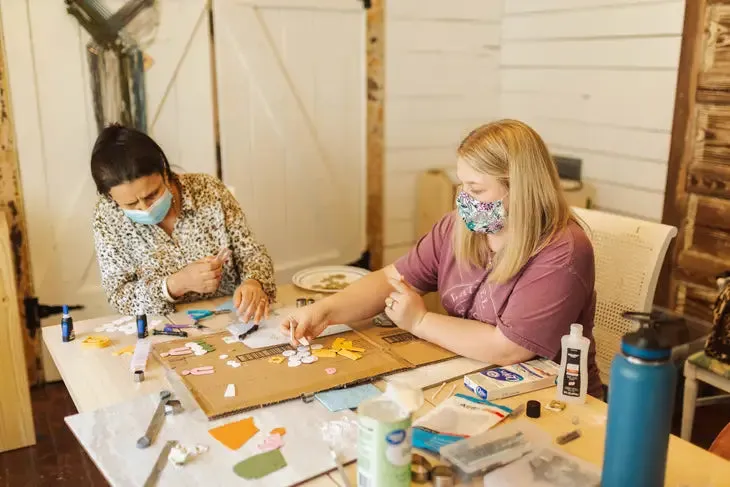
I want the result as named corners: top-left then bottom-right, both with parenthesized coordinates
top-left (500, 0), bottom-right (684, 221)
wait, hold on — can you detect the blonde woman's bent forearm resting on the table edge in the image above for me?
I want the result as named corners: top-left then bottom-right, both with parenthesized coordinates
top-left (413, 313), bottom-right (534, 365)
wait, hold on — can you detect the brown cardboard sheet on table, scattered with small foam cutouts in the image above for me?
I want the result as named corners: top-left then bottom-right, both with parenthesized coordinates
top-left (153, 326), bottom-right (455, 419)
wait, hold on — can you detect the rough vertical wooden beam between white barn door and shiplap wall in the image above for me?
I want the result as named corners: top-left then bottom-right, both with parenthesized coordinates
top-left (366, 0), bottom-right (385, 269)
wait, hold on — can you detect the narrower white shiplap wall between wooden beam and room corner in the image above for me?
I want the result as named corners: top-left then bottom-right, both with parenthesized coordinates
top-left (384, 0), bottom-right (509, 263)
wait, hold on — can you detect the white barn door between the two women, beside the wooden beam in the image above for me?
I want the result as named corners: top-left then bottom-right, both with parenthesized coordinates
top-left (213, 0), bottom-right (366, 282)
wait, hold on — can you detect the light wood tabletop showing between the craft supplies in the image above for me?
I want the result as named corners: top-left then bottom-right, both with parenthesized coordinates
top-left (43, 286), bottom-right (730, 487)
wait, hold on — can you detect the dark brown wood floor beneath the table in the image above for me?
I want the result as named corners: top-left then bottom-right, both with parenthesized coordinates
top-left (0, 383), bottom-right (730, 487)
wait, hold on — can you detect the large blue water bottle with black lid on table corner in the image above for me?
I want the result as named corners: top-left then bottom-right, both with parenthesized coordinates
top-left (601, 313), bottom-right (677, 487)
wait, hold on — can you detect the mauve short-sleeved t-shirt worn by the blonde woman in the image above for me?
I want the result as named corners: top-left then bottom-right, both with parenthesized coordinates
top-left (395, 212), bottom-right (602, 397)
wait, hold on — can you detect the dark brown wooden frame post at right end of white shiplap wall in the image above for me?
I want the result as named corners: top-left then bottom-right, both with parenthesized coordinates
top-left (654, 0), bottom-right (707, 309)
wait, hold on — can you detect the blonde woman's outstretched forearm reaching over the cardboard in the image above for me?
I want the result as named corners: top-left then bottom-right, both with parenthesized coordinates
top-left (317, 269), bottom-right (393, 323)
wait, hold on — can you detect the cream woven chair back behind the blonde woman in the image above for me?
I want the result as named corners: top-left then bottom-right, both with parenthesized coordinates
top-left (572, 207), bottom-right (677, 385)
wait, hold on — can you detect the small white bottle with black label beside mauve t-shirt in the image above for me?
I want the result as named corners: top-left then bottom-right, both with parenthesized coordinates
top-left (557, 323), bottom-right (591, 404)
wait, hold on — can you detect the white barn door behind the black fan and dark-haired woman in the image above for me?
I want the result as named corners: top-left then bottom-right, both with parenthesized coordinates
top-left (0, 0), bottom-right (216, 322)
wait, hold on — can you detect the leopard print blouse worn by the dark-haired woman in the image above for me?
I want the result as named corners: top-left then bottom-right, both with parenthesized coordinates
top-left (93, 174), bottom-right (276, 315)
